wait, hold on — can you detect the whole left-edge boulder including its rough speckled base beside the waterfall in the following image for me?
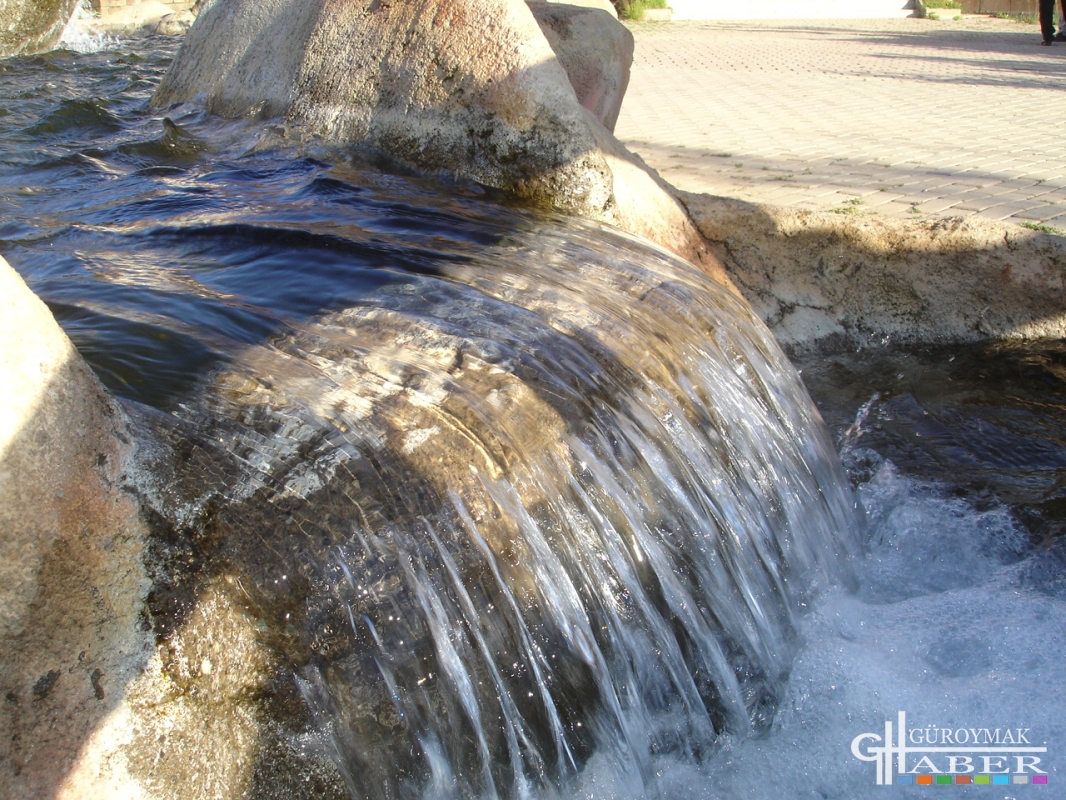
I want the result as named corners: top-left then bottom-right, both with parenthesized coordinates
top-left (0, 258), bottom-right (344, 800)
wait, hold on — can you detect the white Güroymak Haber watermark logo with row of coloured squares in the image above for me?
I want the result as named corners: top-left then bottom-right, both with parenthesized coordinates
top-left (852, 711), bottom-right (1048, 786)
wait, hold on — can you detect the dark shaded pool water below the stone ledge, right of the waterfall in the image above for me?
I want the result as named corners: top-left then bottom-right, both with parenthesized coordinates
top-left (796, 341), bottom-right (1066, 558)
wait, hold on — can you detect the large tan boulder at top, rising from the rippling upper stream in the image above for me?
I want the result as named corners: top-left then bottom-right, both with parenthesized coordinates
top-left (152, 0), bottom-right (723, 277)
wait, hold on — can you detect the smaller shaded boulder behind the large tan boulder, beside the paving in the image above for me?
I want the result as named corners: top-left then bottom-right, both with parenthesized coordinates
top-left (529, 2), bottom-right (633, 132)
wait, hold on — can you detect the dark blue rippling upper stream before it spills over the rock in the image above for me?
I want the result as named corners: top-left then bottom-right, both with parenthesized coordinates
top-left (0, 37), bottom-right (554, 407)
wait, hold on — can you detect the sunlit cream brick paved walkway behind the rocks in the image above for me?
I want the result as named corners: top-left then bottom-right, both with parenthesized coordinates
top-left (615, 16), bottom-right (1066, 230)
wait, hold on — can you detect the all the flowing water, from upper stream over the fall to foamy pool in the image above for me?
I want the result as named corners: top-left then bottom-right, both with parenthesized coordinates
top-left (0, 29), bottom-right (1066, 798)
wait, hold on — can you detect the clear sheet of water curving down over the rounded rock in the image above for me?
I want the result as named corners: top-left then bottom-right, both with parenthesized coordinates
top-left (139, 210), bottom-right (856, 798)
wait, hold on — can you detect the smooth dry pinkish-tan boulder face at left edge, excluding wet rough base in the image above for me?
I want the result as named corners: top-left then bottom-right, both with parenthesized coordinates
top-left (0, 258), bottom-right (150, 798)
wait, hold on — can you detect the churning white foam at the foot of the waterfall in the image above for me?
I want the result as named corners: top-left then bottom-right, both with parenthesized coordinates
top-left (576, 462), bottom-right (1066, 800)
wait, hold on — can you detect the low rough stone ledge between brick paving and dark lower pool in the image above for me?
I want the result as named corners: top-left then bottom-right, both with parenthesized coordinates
top-left (677, 191), bottom-right (1066, 349)
